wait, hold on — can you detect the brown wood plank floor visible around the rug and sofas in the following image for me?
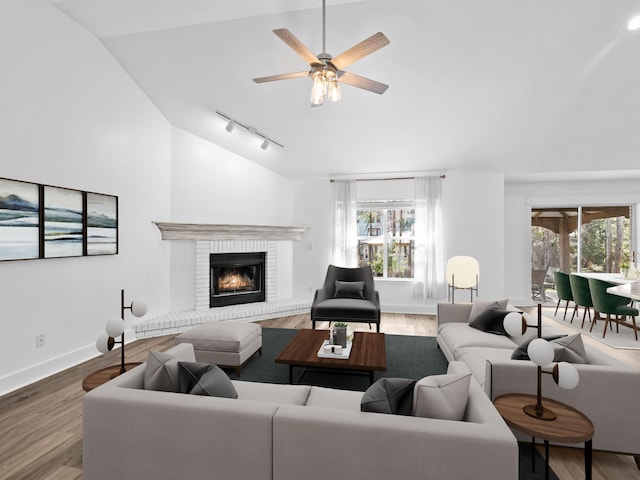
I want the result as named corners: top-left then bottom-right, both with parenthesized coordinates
top-left (0, 314), bottom-right (640, 480)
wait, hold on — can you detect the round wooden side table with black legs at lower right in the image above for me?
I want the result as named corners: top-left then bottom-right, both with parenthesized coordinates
top-left (493, 393), bottom-right (593, 480)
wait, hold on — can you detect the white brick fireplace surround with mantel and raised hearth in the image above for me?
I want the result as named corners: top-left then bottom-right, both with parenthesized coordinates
top-left (133, 223), bottom-right (311, 338)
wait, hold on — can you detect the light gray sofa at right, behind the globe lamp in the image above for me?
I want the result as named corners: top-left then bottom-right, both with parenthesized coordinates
top-left (437, 303), bottom-right (640, 459)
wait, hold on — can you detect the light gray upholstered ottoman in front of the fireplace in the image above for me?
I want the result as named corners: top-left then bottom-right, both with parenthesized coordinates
top-left (176, 322), bottom-right (262, 376)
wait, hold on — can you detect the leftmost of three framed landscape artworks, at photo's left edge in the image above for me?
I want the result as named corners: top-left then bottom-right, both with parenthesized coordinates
top-left (0, 178), bottom-right (40, 260)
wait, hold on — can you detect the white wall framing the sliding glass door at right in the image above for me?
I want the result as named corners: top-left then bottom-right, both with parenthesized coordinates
top-left (504, 179), bottom-right (640, 305)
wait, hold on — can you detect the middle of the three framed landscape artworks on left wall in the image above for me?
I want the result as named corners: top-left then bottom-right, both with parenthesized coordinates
top-left (44, 185), bottom-right (84, 258)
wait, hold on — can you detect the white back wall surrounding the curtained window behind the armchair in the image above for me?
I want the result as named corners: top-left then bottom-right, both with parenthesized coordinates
top-left (294, 172), bottom-right (504, 313)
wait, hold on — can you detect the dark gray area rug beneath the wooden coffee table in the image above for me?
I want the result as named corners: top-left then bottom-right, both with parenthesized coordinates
top-left (227, 328), bottom-right (558, 480)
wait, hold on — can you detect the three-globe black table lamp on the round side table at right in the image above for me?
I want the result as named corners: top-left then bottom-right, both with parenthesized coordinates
top-left (504, 303), bottom-right (580, 421)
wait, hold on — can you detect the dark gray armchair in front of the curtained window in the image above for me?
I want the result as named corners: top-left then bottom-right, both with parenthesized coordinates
top-left (311, 265), bottom-right (380, 332)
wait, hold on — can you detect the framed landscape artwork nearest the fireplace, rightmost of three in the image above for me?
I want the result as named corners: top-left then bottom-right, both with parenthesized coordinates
top-left (86, 192), bottom-right (118, 255)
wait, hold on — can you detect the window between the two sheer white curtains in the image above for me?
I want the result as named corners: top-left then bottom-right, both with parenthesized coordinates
top-left (357, 202), bottom-right (415, 278)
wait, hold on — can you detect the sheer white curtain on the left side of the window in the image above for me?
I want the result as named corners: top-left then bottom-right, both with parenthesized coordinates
top-left (332, 180), bottom-right (358, 267)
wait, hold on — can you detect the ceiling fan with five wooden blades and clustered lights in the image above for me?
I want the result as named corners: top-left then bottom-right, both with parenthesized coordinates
top-left (253, 0), bottom-right (389, 107)
